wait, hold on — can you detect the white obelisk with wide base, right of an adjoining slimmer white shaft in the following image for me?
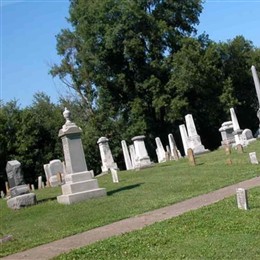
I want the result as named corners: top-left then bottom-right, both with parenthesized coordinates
top-left (185, 114), bottom-right (208, 154)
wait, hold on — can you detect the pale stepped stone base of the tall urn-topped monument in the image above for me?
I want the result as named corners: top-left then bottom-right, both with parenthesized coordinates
top-left (57, 171), bottom-right (106, 204)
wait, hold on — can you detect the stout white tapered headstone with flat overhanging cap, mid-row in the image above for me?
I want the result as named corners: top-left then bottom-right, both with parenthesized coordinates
top-left (132, 135), bottom-right (152, 169)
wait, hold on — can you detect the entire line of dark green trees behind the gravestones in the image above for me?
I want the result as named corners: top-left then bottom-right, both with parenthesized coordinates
top-left (0, 0), bottom-right (260, 190)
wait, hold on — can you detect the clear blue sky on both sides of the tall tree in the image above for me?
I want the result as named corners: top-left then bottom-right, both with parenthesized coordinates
top-left (0, 0), bottom-right (260, 107)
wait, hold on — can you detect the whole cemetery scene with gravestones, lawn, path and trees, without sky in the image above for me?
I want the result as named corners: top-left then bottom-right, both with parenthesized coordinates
top-left (0, 0), bottom-right (260, 260)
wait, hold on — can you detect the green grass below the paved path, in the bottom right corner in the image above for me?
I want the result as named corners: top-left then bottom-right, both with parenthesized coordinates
top-left (55, 188), bottom-right (260, 260)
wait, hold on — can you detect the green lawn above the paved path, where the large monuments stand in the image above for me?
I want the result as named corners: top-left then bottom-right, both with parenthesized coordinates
top-left (0, 141), bottom-right (260, 256)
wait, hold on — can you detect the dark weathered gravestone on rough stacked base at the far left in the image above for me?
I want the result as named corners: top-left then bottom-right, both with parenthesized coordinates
top-left (6, 160), bottom-right (36, 209)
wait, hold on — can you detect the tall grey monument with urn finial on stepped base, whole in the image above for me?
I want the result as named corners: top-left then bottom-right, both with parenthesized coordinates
top-left (57, 108), bottom-right (106, 204)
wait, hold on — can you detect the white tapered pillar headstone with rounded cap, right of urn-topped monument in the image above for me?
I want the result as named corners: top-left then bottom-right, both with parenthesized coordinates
top-left (97, 137), bottom-right (118, 172)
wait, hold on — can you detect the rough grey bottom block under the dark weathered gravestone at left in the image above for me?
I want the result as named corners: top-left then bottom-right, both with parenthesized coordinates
top-left (7, 193), bottom-right (37, 209)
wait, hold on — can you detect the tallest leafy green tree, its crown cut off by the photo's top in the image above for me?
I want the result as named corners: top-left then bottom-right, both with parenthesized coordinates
top-left (51, 0), bottom-right (202, 152)
